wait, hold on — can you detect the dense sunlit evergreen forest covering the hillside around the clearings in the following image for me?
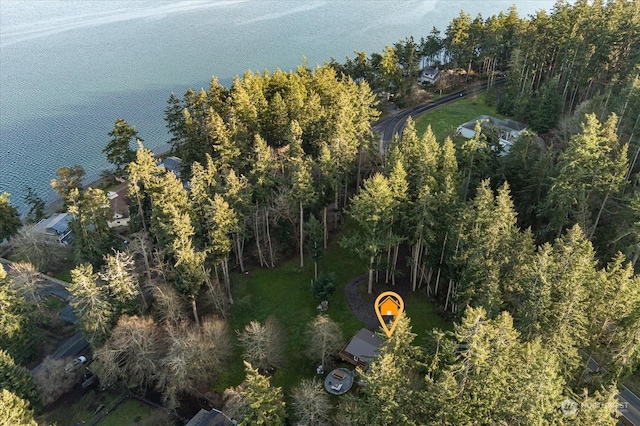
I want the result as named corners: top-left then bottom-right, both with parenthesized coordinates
top-left (2, 0), bottom-right (640, 425)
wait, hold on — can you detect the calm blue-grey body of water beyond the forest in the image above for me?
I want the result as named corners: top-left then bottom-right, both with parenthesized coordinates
top-left (0, 0), bottom-right (554, 211)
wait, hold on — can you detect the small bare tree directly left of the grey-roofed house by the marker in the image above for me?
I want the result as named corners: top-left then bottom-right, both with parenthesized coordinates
top-left (306, 314), bottom-right (345, 367)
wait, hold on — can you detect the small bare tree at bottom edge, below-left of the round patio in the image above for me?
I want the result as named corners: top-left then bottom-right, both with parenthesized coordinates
top-left (291, 379), bottom-right (333, 426)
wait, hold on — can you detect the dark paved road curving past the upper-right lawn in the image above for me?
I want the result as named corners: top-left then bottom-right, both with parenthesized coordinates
top-left (373, 79), bottom-right (505, 152)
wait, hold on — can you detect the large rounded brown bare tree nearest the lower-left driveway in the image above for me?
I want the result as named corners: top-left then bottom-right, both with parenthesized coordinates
top-left (93, 315), bottom-right (165, 388)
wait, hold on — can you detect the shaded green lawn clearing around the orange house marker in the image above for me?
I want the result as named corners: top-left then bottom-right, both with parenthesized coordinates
top-left (214, 222), bottom-right (447, 393)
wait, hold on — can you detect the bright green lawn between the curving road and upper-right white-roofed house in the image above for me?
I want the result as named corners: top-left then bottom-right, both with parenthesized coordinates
top-left (415, 94), bottom-right (505, 141)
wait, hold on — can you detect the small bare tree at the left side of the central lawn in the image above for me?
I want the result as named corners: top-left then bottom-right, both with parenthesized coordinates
top-left (237, 317), bottom-right (286, 371)
